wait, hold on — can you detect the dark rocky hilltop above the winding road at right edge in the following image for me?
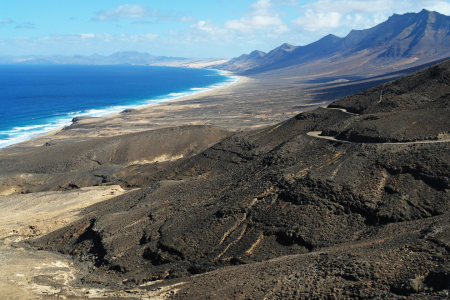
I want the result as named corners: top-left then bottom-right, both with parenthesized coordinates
top-left (323, 61), bottom-right (450, 143)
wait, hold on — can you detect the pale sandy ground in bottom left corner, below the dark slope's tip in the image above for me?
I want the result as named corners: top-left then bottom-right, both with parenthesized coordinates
top-left (0, 238), bottom-right (184, 300)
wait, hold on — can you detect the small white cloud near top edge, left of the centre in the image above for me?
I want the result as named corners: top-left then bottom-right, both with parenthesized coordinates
top-left (92, 4), bottom-right (158, 21)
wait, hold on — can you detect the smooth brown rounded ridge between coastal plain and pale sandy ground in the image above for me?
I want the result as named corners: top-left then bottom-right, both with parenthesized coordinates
top-left (0, 123), bottom-right (231, 194)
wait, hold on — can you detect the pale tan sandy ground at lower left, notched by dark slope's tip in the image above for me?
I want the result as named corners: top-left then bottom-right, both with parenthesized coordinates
top-left (0, 186), bottom-right (183, 300)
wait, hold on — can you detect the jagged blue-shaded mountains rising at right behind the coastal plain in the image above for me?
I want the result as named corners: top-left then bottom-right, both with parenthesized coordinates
top-left (214, 9), bottom-right (450, 75)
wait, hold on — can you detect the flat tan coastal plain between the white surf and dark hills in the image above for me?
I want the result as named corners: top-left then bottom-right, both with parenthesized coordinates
top-left (0, 69), bottom-right (358, 152)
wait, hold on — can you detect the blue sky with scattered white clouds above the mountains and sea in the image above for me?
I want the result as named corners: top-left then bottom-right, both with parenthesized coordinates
top-left (0, 0), bottom-right (450, 58)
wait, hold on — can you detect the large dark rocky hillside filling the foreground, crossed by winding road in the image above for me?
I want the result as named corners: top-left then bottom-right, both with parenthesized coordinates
top-left (11, 58), bottom-right (450, 299)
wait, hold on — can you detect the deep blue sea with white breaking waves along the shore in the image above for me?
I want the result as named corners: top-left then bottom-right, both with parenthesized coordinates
top-left (0, 65), bottom-right (238, 148)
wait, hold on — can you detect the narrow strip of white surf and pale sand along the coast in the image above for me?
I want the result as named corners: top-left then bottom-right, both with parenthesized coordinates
top-left (0, 69), bottom-right (245, 151)
